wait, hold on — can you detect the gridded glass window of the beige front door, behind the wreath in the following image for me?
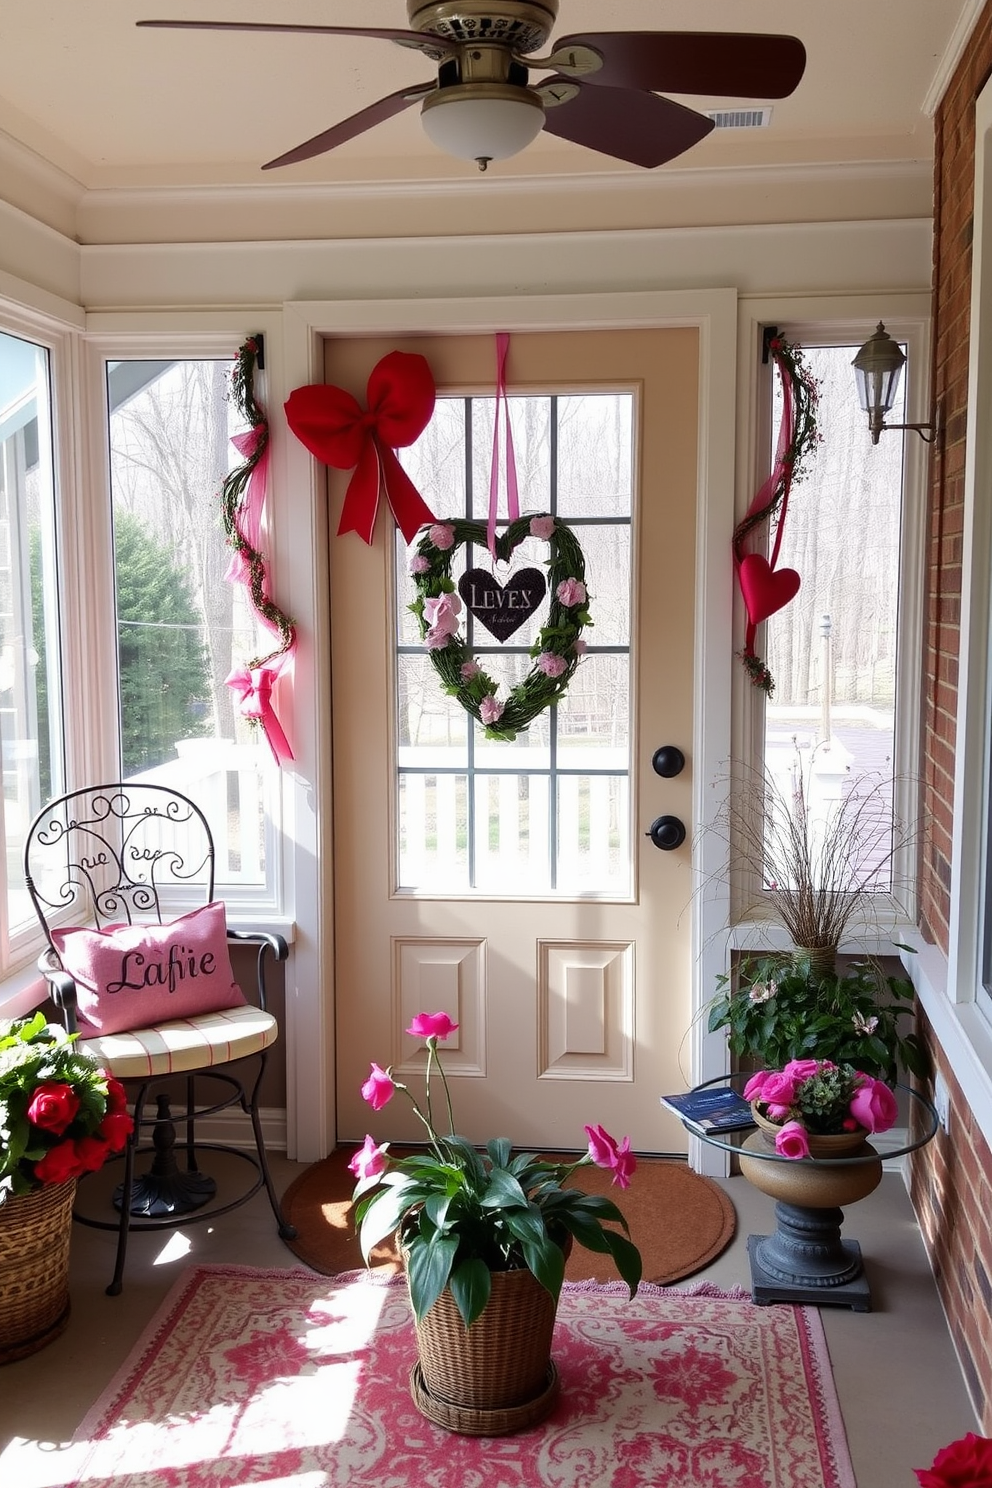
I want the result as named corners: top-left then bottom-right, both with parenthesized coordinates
top-left (394, 393), bottom-right (634, 899)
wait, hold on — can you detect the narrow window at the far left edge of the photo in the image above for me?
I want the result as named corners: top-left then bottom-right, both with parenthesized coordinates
top-left (0, 333), bottom-right (64, 970)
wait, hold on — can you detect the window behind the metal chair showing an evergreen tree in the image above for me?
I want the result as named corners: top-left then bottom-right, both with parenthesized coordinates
top-left (106, 359), bottom-right (278, 899)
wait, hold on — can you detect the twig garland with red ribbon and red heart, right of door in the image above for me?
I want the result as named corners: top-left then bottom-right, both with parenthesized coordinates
top-left (733, 336), bottom-right (819, 696)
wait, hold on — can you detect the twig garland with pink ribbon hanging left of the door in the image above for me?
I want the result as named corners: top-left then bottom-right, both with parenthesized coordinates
top-left (220, 336), bottom-right (296, 763)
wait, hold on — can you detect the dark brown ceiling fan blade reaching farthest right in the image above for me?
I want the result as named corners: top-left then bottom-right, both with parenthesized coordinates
top-left (552, 31), bottom-right (806, 98)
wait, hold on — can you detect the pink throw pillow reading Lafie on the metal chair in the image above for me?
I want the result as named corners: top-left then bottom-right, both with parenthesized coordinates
top-left (52, 903), bottom-right (247, 1033)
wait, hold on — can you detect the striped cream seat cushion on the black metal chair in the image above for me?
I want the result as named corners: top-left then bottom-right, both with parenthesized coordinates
top-left (79, 1006), bottom-right (280, 1080)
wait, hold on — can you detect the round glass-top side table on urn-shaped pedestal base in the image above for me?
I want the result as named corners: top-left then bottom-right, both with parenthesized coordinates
top-left (686, 1074), bottom-right (940, 1312)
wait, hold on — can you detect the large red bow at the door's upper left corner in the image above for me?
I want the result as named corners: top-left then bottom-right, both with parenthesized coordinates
top-left (286, 351), bottom-right (434, 543)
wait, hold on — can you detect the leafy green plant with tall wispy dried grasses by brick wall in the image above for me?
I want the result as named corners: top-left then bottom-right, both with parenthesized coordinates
top-left (708, 748), bottom-right (928, 1082)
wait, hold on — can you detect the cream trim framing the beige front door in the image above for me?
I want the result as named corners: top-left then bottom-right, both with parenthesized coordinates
top-left (280, 289), bottom-right (738, 1171)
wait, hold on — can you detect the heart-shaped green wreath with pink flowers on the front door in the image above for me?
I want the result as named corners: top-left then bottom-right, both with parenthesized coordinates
top-left (410, 512), bottom-right (592, 741)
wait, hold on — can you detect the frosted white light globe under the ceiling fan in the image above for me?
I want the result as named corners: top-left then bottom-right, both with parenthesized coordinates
top-left (421, 83), bottom-right (544, 164)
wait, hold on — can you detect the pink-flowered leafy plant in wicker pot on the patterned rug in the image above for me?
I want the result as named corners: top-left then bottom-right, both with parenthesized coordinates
top-left (351, 1012), bottom-right (641, 1434)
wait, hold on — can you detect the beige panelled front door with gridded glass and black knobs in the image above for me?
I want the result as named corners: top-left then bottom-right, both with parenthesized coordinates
top-left (324, 327), bottom-right (699, 1152)
